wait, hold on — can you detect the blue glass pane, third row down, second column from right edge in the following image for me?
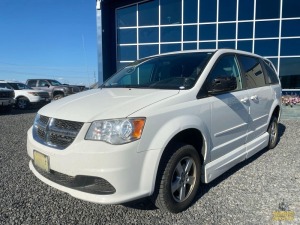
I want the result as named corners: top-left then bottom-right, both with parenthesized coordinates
top-left (254, 39), bottom-right (278, 56)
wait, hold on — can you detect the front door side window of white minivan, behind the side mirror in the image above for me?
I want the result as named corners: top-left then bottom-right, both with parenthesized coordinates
top-left (208, 55), bottom-right (243, 91)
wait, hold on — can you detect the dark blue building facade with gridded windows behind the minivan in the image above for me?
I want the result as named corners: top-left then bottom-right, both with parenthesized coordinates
top-left (97, 0), bottom-right (300, 89)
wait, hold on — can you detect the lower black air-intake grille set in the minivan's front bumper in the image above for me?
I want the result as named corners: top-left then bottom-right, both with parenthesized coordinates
top-left (33, 163), bottom-right (116, 195)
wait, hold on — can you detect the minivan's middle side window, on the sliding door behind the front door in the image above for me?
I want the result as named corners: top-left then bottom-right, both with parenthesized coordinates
top-left (239, 55), bottom-right (266, 88)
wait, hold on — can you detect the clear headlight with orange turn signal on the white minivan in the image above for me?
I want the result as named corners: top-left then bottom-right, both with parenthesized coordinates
top-left (85, 118), bottom-right (146, 145)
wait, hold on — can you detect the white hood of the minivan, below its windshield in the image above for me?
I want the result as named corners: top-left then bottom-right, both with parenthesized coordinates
top-left (38, 88), bottom-right (179, 122)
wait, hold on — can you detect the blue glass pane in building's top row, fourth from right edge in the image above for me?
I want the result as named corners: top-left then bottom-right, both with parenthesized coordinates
top-left (219, 0), bottom-right (236, 21)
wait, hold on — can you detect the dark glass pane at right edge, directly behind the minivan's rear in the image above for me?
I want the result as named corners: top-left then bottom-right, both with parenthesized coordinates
top-left (279, 57), bottom-right (300, 89)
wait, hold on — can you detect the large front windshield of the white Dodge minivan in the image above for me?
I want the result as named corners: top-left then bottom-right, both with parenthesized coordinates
top-left (102, 52), bottom-right (212, 89)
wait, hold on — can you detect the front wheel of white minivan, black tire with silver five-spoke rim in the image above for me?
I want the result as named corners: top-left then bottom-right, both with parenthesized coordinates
top-left (151, 144), bottom-right (201, 213)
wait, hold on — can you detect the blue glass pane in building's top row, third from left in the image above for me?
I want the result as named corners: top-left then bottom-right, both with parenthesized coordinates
top-left (160, 0), bottom-right (181, 24)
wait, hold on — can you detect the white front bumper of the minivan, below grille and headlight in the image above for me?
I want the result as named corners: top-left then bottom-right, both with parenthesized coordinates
top-left (27, 127), bottom-right (160, 204)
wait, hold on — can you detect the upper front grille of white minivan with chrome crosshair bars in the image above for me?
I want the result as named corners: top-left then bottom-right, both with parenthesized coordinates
top-left (33, 114), bottom-right (83, 150)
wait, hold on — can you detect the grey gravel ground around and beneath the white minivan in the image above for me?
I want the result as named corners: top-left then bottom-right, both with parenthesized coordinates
top-left (0, 110), bottom-right (300, 225)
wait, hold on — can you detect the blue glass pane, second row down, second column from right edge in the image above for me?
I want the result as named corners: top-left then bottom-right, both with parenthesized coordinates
top-left (255, 21), bottom-right (279, 38)
